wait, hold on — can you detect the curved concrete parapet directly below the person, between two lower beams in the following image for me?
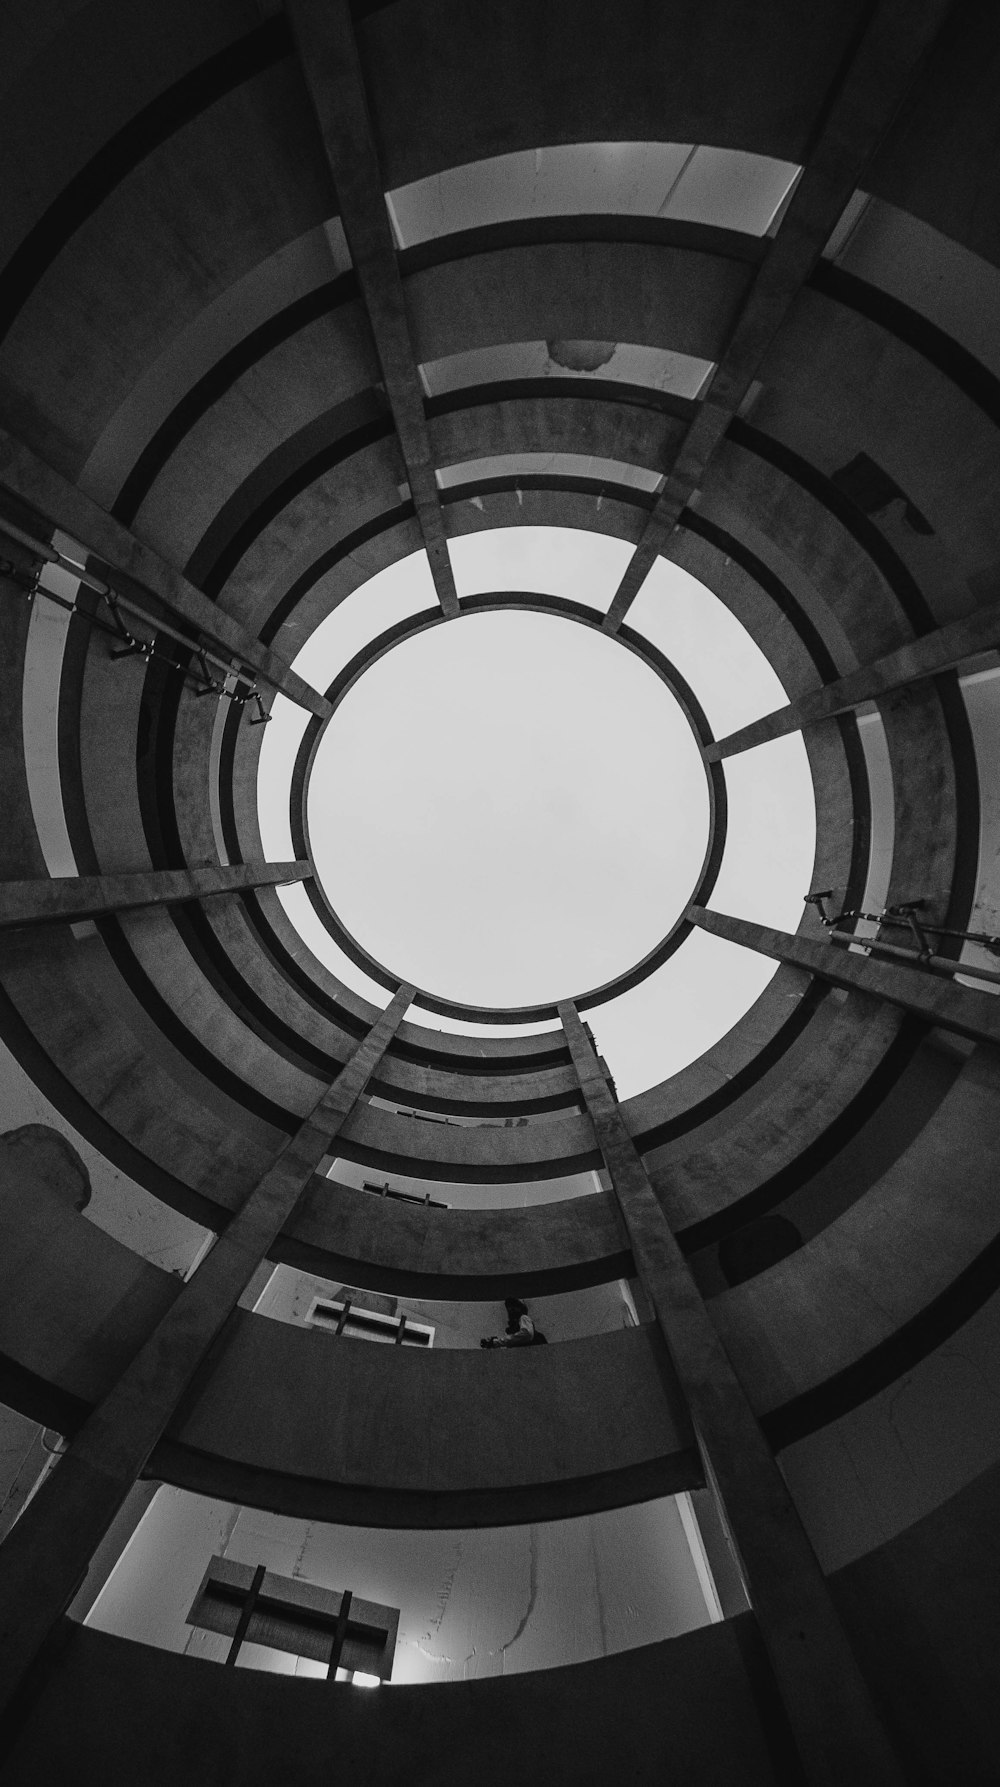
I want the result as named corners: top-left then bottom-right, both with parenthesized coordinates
top-left (162, 1312), bottom-right (700, 1526)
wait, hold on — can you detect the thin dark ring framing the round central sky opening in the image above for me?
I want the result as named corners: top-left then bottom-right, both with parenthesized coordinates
top-left (289, 590), bottom-right (727, 1026)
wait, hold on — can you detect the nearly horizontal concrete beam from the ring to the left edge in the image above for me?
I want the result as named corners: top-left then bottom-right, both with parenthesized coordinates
top-left (0, 861), bottom-right (313, 931)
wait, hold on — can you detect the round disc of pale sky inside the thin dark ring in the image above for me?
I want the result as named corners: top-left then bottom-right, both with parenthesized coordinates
top-left (307, 613), bottom-right (711, 1006)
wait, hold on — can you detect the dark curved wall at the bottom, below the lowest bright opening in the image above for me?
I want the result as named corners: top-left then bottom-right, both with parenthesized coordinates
top-left (5, 1623), bottom-right (788, 1787)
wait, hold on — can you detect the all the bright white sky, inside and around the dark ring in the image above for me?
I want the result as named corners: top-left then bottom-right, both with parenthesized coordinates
top-left (259, 527), bottom-right (814, 1095)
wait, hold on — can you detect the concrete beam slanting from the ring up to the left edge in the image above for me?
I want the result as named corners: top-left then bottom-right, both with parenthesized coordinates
top-left (0, 429), bottom-right (334, 720)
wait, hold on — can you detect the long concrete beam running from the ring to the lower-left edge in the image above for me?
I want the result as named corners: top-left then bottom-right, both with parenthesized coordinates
top-left (0, 986), bottom-right (414, 1712)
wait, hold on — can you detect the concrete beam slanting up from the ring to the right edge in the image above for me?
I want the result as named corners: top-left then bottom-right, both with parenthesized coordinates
top-left (705, 602), bottom-right (1000, 763)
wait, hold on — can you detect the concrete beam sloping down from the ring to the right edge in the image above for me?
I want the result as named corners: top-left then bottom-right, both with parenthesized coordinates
top-left (688, 906), bottom-right (1000, 1044)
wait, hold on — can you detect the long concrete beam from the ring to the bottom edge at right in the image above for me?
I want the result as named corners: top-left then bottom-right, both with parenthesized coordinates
top-left (559, 1001), bottom-right (902, 1787)
